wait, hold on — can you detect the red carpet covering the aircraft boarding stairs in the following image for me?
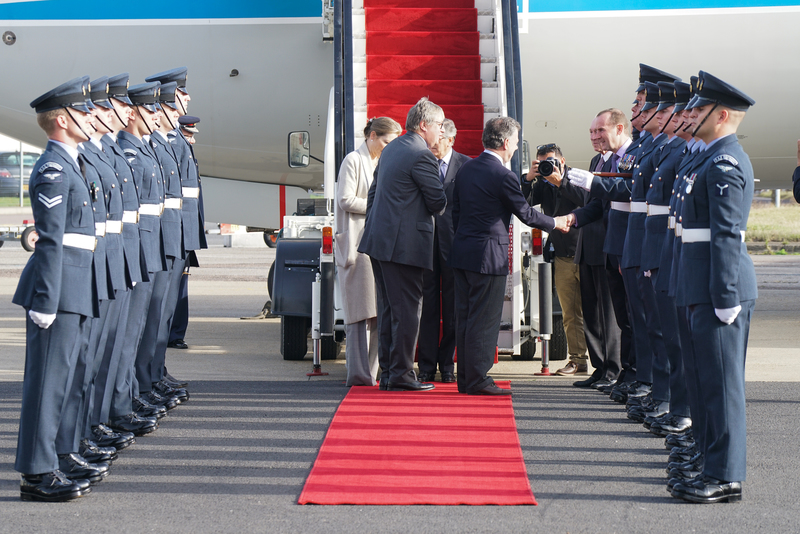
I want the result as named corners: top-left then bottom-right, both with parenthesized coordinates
top-left (364, 0), bottom-right (483, 157)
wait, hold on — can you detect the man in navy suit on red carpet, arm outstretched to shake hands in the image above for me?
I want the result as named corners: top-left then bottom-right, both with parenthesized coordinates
top-left (450, 117), bottom-right (568, 395)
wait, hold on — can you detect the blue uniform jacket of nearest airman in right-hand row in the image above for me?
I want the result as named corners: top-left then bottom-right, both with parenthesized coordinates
top-left (677, 134), bottom-right (758, 308)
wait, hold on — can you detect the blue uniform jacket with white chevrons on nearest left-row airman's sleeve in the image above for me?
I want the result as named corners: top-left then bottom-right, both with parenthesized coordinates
top-left (12, 143), bottom-right (98, 317)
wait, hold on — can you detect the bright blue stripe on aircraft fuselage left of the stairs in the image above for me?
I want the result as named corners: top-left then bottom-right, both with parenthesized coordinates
top-left (0, 0), bottom-right (322, 20)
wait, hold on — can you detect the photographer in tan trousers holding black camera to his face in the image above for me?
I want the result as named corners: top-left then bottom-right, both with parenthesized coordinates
top-left (522, 143), bottom-right (588, 376)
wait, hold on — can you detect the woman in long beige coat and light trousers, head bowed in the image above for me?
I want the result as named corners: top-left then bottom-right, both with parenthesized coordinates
top-left (335, 117), bottom-right (402, 386)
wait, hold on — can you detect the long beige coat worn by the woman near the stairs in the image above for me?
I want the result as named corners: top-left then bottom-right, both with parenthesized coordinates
top-left (335, 143), bottom-right (378, 324)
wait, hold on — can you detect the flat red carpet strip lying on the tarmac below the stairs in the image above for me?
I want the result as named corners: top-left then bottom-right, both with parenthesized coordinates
top-left (298, 382), bottom-right (536, 505)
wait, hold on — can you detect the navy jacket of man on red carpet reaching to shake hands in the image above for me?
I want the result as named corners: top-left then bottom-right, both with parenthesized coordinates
top-left (450, 152), bottom-right (555, 275)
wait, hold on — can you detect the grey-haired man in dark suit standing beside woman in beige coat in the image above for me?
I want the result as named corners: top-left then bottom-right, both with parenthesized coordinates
top-left (358, 98), bottom-right (447, 391)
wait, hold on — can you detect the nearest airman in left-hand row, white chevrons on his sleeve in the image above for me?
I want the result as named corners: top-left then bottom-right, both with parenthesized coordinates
top-left (13, 78), bottom-right (98, 501)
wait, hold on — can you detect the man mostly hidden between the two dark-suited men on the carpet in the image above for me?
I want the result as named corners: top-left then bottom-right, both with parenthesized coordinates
top-left (418, 119), bottom-right (470, 382)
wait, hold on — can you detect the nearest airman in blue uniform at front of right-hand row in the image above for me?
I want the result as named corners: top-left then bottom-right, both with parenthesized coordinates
top-left (672, 71), bottom-right (757, 503)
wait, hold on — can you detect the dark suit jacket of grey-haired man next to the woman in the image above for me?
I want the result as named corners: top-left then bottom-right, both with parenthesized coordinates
top-left (358, 132), bottom-right (447, 270)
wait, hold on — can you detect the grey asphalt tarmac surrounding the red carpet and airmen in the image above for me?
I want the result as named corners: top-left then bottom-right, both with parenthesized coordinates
top-left (0, 238), bottom-right (800, 533)
